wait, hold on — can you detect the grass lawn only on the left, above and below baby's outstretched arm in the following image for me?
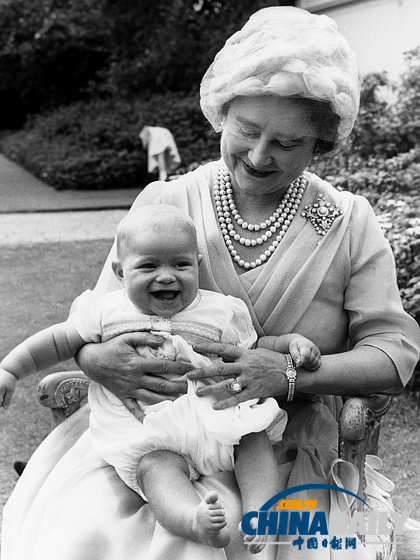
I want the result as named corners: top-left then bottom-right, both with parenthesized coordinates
top-left (0, 240), bottom-right (111, 520)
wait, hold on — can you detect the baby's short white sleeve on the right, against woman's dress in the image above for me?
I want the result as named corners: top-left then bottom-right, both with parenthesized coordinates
top-left (220, 296), bottom-right (257, 348)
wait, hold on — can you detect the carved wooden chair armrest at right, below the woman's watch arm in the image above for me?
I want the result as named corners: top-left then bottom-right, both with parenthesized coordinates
top-left (339, 395), bottom-right (392, 509)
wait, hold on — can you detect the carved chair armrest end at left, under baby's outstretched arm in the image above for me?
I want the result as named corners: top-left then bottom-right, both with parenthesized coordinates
top-left (37, 371), bottom-right (91, 428)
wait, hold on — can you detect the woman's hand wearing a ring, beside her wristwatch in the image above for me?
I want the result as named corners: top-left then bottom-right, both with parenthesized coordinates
top-left (187, 343), bottom-right (288, 410)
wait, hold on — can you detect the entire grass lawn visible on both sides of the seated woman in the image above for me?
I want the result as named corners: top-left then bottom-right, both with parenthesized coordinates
top-left (0, 241), bottom-right (420, 520)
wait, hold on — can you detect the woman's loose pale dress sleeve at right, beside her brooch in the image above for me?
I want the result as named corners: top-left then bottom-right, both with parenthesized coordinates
top-left (345, 196), bottom-right (420, 385)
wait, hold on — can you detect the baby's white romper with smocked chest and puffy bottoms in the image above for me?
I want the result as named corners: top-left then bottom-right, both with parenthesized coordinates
top-left (70, 289), bottom-right (287, 500)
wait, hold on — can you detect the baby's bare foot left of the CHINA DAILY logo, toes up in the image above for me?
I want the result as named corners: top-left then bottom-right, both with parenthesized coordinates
top-left (193, 492), bottom-right (230, 548)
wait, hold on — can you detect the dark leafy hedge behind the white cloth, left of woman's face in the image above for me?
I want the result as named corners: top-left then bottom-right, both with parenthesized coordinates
top-left (0, 94), bottom-right (219, 189)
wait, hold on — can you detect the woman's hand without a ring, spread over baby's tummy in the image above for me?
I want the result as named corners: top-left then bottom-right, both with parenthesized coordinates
top-left (76, 332), bottom-right (192, 420)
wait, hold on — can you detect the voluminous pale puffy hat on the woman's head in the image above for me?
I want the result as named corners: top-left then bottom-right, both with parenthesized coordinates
top-left (200, 6), bottom-right (360, 153)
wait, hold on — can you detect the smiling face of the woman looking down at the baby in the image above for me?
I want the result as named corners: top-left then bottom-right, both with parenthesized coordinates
top-left (221, 96), bottom-right (316, 196)
